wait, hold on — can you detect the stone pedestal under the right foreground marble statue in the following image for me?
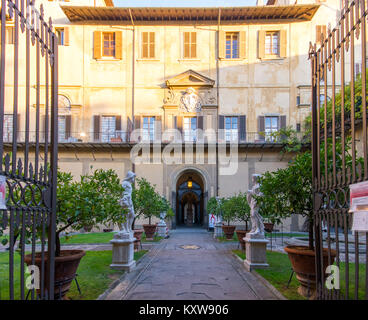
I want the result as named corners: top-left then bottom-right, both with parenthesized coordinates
top-left (244, 233), bottom-right (269, 271)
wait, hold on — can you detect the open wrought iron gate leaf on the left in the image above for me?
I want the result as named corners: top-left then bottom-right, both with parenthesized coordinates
top-left (0, 0), bottom-right (58, 300)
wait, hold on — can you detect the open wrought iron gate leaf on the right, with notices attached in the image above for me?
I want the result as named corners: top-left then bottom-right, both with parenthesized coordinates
top-left (310, 0), bottom-right (368, 299)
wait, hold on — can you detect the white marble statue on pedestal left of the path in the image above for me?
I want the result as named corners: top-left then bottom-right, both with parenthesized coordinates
top-left (120, 171), bottom-right (136, 233)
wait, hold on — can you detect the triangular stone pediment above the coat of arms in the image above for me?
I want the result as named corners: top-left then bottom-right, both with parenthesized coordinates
top-left (166, 70), bottom-right (215, 88)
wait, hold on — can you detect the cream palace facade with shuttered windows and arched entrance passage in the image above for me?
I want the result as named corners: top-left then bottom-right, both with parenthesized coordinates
top-left (4, 0), bottom-right (344, 231)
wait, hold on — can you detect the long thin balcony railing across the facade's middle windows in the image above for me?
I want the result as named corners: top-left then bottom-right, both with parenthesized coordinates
top-left (3, 130), bottom-right (307, 144)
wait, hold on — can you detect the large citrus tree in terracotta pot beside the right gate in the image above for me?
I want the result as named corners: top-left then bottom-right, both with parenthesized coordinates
top-left (259, 151), bottom-right (336, 297)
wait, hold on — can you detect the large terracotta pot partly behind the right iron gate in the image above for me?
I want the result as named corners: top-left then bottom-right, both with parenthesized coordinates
top-left (284, 246), bottom-right (336, 299)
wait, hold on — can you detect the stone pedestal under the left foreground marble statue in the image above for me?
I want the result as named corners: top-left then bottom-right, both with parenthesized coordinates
top-left (110, 232), bottom-right (136, 272)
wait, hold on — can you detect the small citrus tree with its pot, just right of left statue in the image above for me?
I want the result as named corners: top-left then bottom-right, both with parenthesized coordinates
top-left (133, 178), bottom-right (162, 240)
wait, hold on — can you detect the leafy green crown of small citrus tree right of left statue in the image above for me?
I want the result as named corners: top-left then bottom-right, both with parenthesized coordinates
top-left (132, 178), bottom-right (170, 224)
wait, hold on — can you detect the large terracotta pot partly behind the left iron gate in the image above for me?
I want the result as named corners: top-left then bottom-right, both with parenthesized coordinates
top-left (24, 250), bottom-right (86, 300)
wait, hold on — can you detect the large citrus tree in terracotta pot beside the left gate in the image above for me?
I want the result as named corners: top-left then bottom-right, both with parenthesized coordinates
top-left (25, 170), bottom-right (125, 299)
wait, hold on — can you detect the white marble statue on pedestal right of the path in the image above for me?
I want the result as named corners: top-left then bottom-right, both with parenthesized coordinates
top-left (247, 174), bottom-right (264, 237)
